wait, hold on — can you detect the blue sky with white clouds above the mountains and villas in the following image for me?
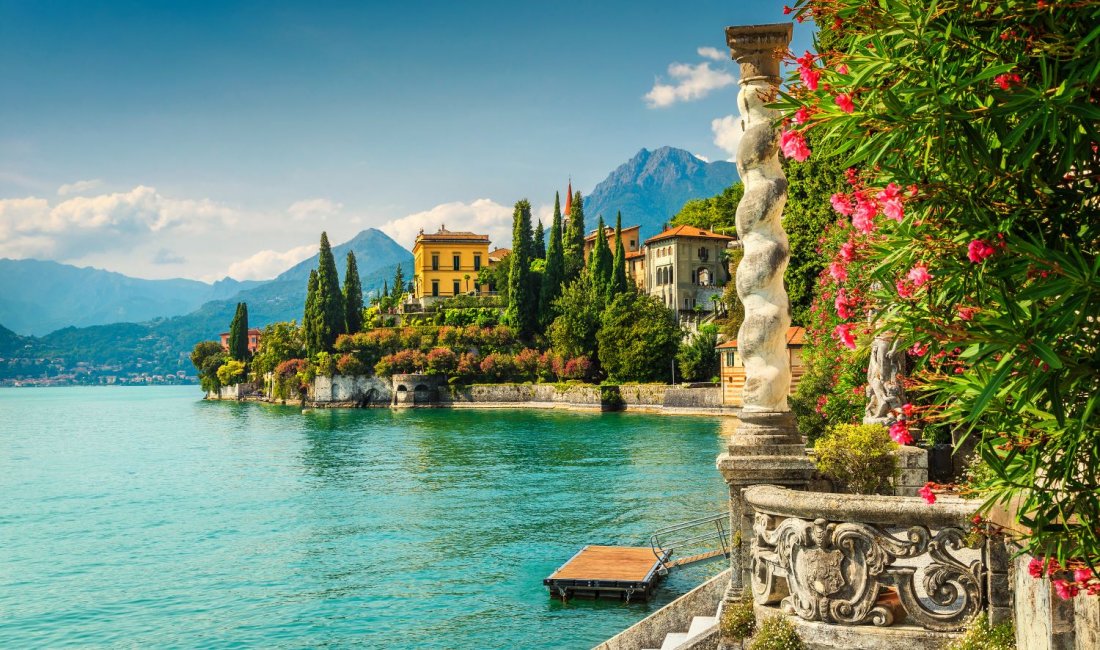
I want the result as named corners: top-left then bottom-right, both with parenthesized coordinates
top-left (0, 0), bottom-right (812, 282)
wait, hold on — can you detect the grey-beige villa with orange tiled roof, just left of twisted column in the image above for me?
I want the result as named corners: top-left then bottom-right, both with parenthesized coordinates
top-left (642, 225), bottom-right (735, 312)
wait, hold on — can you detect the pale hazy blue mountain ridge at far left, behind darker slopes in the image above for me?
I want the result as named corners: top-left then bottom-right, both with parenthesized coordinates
top-left (0, 258), bottom-right (261, 335)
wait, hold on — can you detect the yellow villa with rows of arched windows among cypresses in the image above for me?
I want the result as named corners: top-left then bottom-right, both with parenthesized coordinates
top-left (413, 225), bottom-right (488, 306)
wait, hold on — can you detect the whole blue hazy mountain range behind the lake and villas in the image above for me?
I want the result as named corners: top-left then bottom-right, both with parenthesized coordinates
top-left (0, 146), bottom-right (737, 379)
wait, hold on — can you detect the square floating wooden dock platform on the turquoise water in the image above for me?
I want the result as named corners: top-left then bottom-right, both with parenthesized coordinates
top-left (542, 546), bottom-right (668, 602)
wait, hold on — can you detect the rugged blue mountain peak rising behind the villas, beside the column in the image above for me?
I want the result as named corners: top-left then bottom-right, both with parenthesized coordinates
top-left (584, 146), bottom-right (738, 239)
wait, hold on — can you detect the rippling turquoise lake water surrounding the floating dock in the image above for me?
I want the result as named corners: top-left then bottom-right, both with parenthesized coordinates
top-left (0, 386), bottom-right (726, 648)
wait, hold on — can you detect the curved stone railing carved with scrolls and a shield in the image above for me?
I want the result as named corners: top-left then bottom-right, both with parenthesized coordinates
top-left (745, 485), bottom-right (1007, 632)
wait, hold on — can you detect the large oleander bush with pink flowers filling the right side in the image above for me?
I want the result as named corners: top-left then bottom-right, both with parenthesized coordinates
top-left (781, 0), bottom-right (1100, 568)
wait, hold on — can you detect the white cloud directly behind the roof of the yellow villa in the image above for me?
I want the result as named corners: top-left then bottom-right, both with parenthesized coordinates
top-left (378, 199), bottom-right (513, 249)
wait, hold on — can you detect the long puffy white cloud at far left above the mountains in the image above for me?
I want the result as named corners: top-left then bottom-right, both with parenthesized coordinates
top-left (0, 185), bottom-right (240, 261)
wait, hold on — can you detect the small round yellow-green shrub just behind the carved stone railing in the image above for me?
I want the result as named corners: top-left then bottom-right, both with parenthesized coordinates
top-left (814, 425), bottom-right (898, 494)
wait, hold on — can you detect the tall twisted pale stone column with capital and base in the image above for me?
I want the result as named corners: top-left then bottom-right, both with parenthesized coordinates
top-left (718, 23), bottom-right (813, 599)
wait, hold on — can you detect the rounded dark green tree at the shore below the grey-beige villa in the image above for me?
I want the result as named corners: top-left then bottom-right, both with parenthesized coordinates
top-left (596, 291), bottom-right (681, 382)
